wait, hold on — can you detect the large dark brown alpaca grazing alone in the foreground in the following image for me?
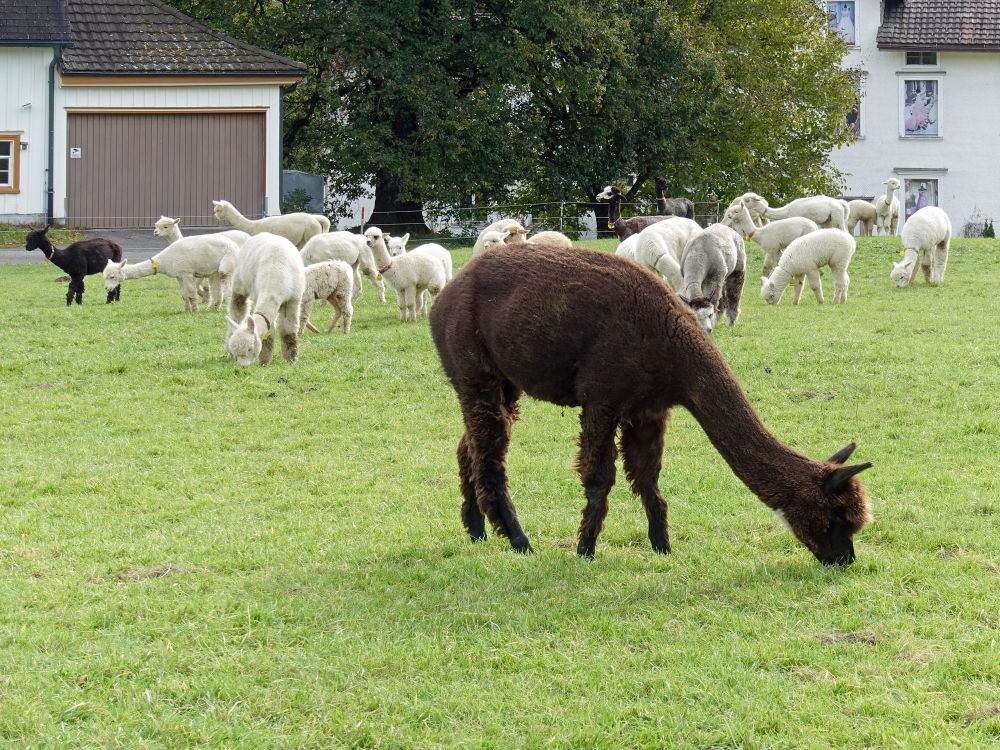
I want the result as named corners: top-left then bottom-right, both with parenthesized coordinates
top-left (430, 245), bottom-right (871, 564)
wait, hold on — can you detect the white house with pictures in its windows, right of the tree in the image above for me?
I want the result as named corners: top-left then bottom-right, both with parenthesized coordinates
top-left (827, 0), bottom-right (1000, 234)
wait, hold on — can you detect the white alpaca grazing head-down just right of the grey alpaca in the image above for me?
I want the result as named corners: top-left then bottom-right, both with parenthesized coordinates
top-left (760, 229), bottom-right (856, 305)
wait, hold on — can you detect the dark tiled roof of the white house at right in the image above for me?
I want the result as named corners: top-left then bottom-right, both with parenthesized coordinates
top-left (876, 0), bottom-right (1000, 50)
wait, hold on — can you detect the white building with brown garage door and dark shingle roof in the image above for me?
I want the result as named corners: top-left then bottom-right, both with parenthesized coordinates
top-left (0, 0), bottom-right (306, 227)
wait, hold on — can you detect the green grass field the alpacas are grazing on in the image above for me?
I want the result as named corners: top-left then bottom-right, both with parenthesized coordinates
top-left (0, 238), bottom-right (1000, 749)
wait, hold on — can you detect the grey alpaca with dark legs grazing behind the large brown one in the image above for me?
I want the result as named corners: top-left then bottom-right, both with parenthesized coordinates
top-left (681, 224), bottom-right (747, 333)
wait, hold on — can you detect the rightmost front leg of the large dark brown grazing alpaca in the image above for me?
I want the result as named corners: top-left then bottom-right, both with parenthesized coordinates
top-left (621, 410), bottom-right (670, 554)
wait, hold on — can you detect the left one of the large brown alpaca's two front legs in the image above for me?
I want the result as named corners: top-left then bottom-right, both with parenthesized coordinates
top-left (576, 406), bottom-right (618, 558)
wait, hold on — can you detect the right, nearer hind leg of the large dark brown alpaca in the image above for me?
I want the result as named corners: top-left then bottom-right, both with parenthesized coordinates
top-left (459, 382), bottom-right (533, 552)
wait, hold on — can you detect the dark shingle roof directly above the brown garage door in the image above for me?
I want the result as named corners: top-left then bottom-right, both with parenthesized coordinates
top-left (61, 0), bottom-right (306, 76)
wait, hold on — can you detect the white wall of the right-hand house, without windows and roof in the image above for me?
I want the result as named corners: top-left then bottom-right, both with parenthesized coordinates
top-left (831, 0), bottom-right (1000, 234)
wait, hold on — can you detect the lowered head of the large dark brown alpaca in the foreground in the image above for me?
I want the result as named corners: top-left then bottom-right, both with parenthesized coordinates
top-left (775, 443), bottom-right (872, 565)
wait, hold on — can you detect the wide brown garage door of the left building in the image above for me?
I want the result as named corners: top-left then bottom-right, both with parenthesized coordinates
top-left (66, 112), bottom-right (265, 228)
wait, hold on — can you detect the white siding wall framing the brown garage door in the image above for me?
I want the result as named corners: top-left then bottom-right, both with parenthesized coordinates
top-left (54, 81), bottom-right (281, 225)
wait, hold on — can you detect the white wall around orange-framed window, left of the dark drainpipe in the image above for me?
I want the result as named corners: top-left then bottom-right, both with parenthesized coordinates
top-left (0, 47), bottom-right (53, 222)
